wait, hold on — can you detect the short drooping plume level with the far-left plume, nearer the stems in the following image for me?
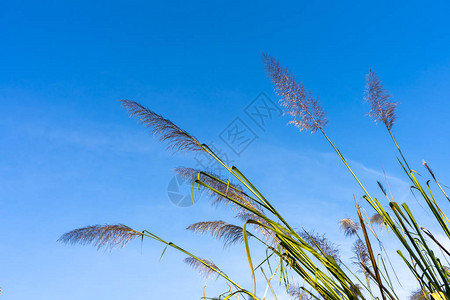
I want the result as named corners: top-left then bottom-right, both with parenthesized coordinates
top-left (186, 221), bottom-right (252, 247)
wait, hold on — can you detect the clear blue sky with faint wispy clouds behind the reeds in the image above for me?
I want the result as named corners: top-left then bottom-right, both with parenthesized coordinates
top-left (0, 0), bottom-right (450, 300)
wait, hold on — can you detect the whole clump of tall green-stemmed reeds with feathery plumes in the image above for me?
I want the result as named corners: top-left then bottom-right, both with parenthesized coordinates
top-left (59, 54), bottom-right (450, 300)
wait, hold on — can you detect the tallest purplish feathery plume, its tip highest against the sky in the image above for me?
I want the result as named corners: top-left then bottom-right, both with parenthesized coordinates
top-left (263, 53), bottom-right (328, 133)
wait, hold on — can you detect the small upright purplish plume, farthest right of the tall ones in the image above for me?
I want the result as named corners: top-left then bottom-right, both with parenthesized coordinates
top-left (364, 69), bottom-right (398, 130)
